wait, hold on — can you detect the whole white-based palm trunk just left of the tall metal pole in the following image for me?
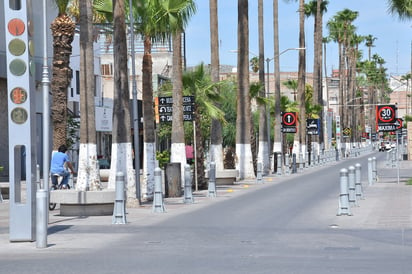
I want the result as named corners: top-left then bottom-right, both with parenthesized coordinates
top-left (109, 0), bottom-right (138, 206)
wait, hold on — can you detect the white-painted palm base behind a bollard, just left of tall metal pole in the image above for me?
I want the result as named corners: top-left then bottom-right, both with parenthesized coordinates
top-left (108, 143), bottom-right (138, 206)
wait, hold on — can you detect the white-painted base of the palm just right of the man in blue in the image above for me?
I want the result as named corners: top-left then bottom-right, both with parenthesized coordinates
top-left (76, 144), bottom-right (102, 191)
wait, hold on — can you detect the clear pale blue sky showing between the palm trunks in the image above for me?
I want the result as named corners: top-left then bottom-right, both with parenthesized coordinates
top-left (186, 0), bottom-right (412, 75)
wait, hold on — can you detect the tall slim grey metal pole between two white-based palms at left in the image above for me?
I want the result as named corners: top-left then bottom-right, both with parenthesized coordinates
top-left (129, 0), bottom-right (142, 205)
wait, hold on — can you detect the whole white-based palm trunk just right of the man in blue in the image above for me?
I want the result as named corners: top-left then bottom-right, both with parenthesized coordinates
top-left (76, 0), bottom-right (101, 191)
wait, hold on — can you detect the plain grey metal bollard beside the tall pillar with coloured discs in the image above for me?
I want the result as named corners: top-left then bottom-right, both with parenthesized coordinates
top-left (36, 189), bottom-right (49, 248)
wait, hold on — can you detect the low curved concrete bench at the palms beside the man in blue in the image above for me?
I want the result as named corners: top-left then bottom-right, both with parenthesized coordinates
top-left (50, 189), bottom-right (115, 216)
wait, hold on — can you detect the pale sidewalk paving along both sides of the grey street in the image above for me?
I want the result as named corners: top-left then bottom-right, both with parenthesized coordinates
top-left (0, 155), bottom-right (412, 252)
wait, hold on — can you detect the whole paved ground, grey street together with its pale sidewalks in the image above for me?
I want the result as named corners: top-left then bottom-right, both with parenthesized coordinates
top-left (0, 152), bottom-right (412, 273)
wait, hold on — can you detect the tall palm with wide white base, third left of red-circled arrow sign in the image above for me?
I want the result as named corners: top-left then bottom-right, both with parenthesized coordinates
top-left (236, 0), bottom-right (255, 179)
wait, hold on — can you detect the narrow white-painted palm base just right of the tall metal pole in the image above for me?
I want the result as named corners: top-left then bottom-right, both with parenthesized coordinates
top-left (141, 143), bottom-right (156, 199)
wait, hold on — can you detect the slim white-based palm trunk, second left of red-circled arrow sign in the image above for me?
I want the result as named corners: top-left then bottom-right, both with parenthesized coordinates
top-left (258, 0), bottom-right (270, 175)
